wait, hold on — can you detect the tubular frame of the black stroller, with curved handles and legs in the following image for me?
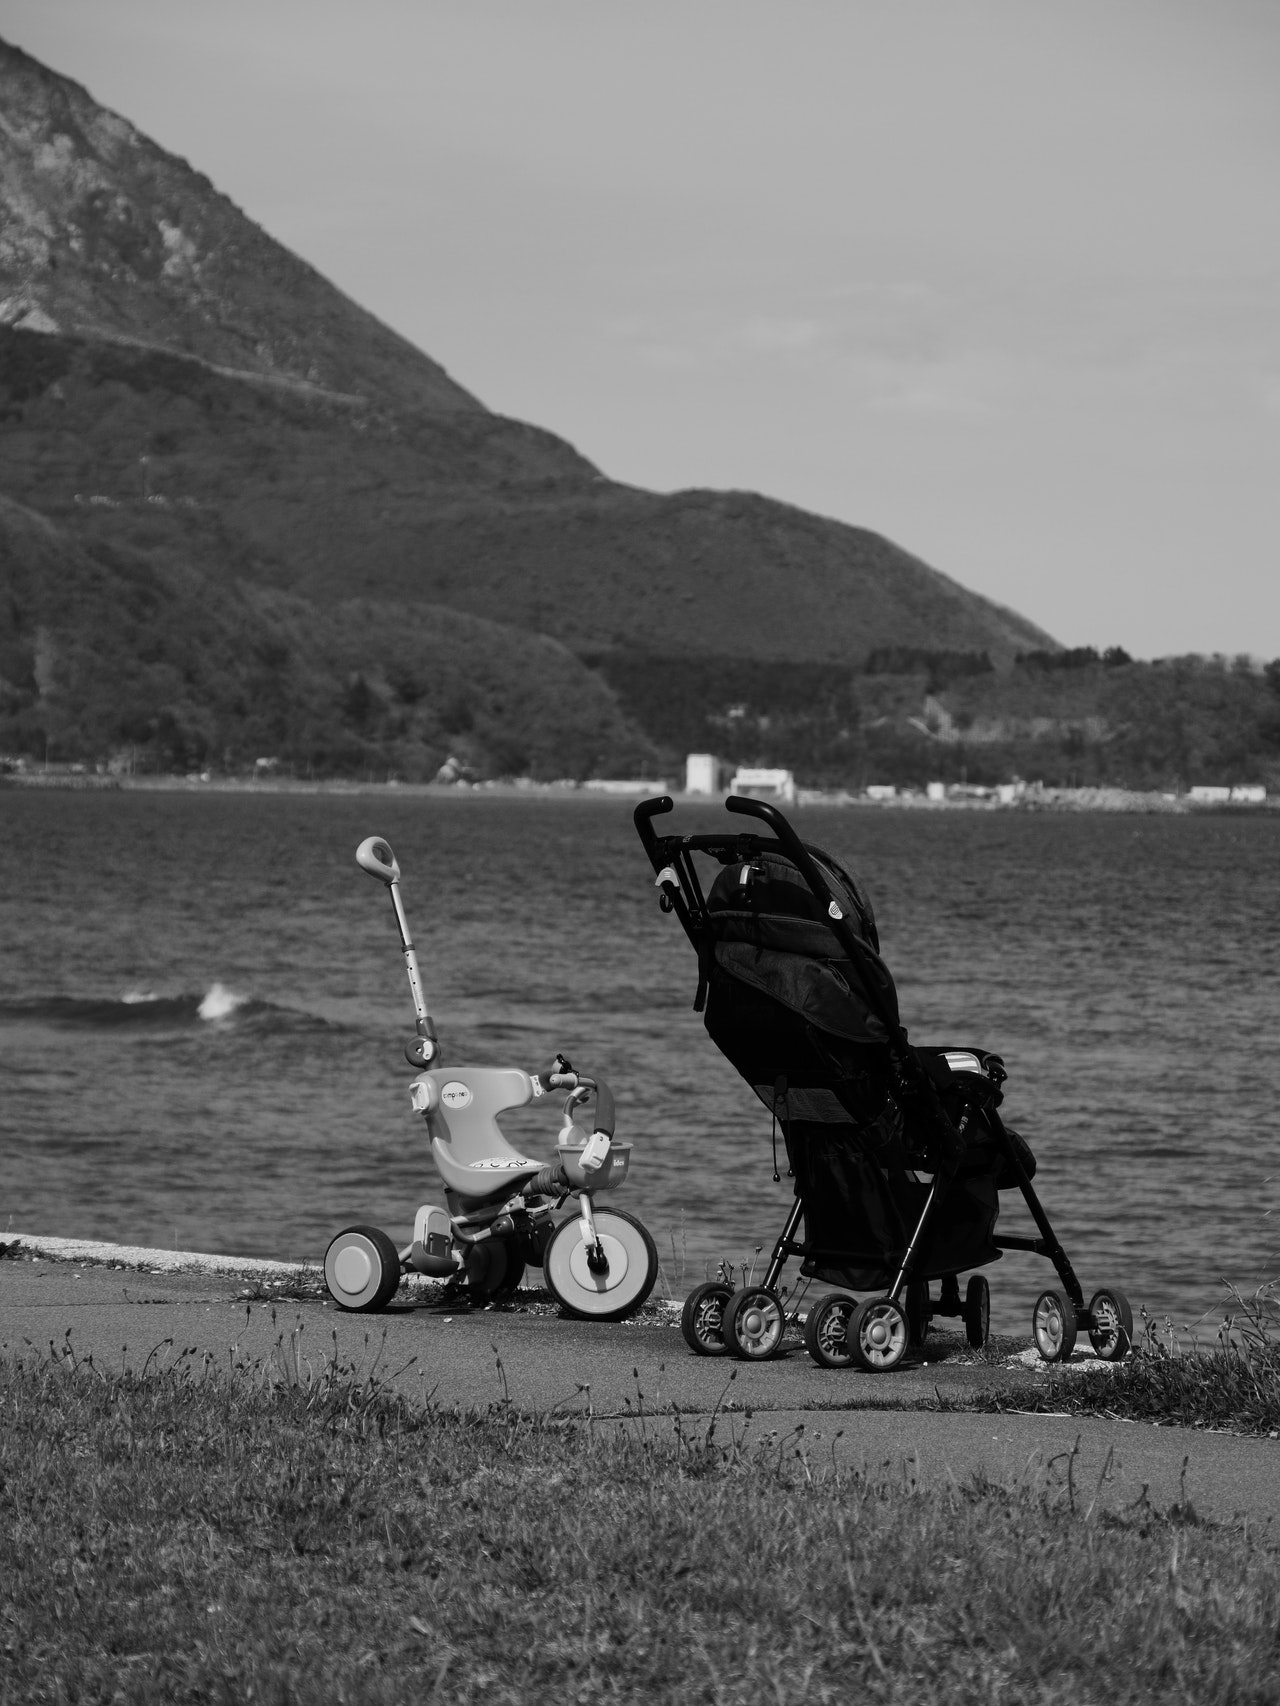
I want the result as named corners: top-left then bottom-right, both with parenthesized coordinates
top-left (633, 795), bottom-right (1132, 1367)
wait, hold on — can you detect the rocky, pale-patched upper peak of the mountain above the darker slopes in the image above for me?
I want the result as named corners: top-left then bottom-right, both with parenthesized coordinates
top-left (0, 41), bottom-right (481, 413)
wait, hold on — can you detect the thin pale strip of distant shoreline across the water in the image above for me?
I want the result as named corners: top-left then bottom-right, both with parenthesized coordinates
top-left (0, 771), bottom-right (1280, 817)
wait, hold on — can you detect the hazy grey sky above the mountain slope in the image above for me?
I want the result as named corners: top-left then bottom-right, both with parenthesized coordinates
top-left (10, 0), bottom-right (1280, 659)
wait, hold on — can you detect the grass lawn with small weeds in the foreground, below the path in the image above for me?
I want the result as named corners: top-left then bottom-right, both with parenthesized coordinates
top-left (0, 1336), bottom-right (1280, 1706)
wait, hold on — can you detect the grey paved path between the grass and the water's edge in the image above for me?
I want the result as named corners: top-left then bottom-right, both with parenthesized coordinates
top-left (0, 1261), bottom-right (1280, 1544)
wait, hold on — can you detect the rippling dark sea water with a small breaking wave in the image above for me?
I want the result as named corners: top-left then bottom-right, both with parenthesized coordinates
top-left (0, 790), bottom-right (1280, 1329)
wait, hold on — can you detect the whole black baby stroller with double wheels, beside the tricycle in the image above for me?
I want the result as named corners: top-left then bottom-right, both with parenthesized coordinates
top-left (635, 797), bottom-right (1133, 1370)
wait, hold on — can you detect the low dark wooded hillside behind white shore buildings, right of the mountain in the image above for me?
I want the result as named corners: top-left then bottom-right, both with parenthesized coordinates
top-left (599, 647), bottom-right (1280, 790)
